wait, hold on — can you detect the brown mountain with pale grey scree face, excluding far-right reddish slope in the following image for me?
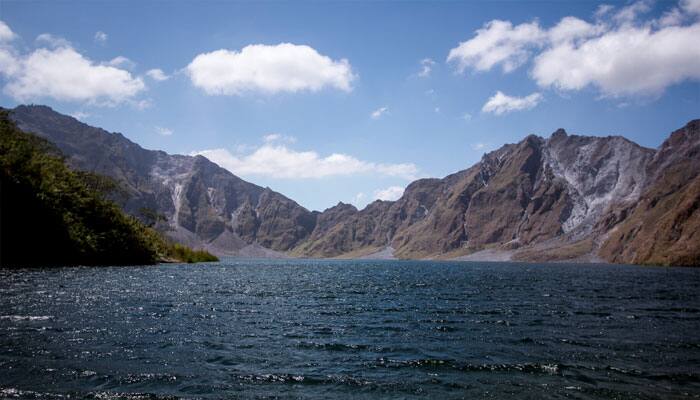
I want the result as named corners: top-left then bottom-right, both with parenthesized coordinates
top-left (298, 126), bottom-right (654, 260)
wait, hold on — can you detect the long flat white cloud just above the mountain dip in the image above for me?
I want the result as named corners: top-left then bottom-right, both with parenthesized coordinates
top-left (192, 143), bottom-right (418, 180)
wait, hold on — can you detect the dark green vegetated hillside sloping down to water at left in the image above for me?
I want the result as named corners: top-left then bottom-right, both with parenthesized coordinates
top-left (0, 110), bottom-right (216, 266)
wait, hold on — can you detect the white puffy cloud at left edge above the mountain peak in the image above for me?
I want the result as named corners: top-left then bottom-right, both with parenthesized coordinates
top-left (0, 47), bottom-right (146, 105)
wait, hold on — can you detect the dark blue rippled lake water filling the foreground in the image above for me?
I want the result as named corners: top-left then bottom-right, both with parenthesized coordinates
top-left (0, 261), bottom-right (700, 399)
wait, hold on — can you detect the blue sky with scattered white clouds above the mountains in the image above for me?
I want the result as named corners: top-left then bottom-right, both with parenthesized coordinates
top-left (0, 0), bottom-right (700, 210)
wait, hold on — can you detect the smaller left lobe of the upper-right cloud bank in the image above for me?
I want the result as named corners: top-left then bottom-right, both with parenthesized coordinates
top-left (447, 20), bottom-right (546, 72)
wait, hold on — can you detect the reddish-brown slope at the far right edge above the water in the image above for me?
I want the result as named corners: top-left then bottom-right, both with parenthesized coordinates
top-left (600, 120), bottom-right (700, 265)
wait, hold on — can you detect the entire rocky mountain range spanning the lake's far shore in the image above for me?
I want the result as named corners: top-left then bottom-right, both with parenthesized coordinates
top-left (6, 106), bottom-right (700, 265)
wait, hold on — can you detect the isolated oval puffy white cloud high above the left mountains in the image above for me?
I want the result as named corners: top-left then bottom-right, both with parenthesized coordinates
top-left (187, 43), bottom-right (355, 95)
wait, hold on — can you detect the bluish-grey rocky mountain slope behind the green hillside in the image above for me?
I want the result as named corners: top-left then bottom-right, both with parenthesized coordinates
top-left (11, 106), bottom-right (316, 255)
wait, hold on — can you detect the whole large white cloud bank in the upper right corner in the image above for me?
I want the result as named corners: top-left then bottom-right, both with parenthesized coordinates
top-left (448, 0), bottom-right (700, 97)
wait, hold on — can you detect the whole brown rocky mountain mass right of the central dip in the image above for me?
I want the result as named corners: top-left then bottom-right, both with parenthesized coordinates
top-left (288, 121), bottom-right (700, 265)
